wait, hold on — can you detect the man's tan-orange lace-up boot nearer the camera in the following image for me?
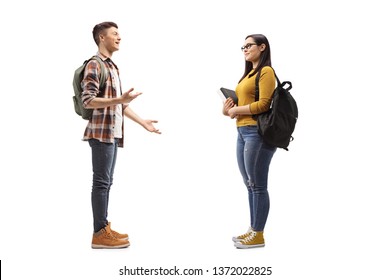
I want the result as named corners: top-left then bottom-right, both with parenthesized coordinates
top-left (91, 225), bottom-right (130, 249)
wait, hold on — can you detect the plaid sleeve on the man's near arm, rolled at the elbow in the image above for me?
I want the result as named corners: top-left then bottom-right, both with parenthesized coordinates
top-left (81, 60), bottom-right (100, 107)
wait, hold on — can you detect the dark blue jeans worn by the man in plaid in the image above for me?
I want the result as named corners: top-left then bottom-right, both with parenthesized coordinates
top-left (88, 139), bottom-right (118, 232)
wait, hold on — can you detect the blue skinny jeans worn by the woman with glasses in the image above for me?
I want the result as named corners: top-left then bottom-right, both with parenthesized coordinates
top-left (237, 126), bottom-right (276, 231)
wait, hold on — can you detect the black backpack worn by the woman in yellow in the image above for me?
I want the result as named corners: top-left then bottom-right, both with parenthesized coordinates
top-left (255, 68), bottom-right (298, 151)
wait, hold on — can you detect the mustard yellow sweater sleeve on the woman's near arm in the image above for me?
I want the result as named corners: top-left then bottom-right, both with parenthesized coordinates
top-left (249, 67), bottom-right (275, 115)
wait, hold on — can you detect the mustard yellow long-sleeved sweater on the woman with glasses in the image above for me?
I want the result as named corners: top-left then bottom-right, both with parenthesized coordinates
top-left (236, 66), bottom-right (275, 126)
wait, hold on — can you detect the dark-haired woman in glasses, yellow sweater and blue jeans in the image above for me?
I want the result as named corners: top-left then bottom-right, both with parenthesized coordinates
top-left (223, 34), bottom-right (276, 249)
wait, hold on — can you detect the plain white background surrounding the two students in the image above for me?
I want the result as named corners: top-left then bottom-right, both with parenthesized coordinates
top-left (0, 0), bottom-right (390, 279)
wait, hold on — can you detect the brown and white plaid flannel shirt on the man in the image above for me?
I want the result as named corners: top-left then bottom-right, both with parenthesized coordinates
top-left (81, 54), bottom-right (125, 147)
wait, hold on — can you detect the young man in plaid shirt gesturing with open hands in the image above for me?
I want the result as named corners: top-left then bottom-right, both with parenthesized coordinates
top-left (81, 22), bottom-right (161, 248)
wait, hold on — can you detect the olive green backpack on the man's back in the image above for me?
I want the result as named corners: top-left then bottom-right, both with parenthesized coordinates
top-left (73, 55), bottom-right (108, 120)
